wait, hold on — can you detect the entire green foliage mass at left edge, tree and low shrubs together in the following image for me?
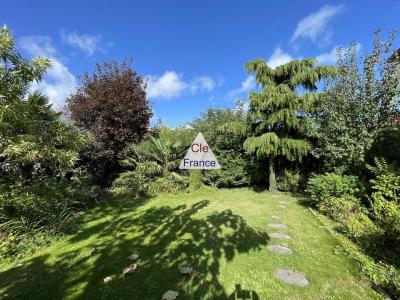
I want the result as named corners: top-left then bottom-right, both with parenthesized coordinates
top-left (0, 28), bottom-right (98, 258)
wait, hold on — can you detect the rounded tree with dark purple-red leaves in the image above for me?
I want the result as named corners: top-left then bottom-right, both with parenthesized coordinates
top-left (67, 60), bottom-right (152, 185)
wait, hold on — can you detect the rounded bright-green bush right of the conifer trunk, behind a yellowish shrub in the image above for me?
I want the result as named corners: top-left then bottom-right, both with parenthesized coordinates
top-left (306, 173), bottom-right (360, 205)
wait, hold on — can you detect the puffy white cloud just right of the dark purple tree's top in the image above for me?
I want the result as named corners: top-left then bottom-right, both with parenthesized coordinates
top-left (146, 71), bottom-right (219, 99)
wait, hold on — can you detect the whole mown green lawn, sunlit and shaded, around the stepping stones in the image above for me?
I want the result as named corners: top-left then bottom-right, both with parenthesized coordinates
top-left (0, 189), bottom-right (381, 300)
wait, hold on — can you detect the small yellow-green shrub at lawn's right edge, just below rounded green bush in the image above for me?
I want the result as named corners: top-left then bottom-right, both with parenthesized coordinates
top-left (317, 197), bottom-right (362, 224)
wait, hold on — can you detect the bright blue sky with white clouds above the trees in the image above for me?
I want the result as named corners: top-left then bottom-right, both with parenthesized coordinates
top-left (0, 0), bottom-right (400, 126)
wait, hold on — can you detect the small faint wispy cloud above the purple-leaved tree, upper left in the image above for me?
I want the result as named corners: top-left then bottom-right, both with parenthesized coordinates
top-left (60, 32), bottom-right (107, 56)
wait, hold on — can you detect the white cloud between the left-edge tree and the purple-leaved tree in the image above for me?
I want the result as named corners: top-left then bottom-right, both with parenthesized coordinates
top-left (19, 36), bottom-right (77, 109)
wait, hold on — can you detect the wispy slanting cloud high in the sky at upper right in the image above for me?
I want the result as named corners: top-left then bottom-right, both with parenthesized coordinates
top-left (290, 5), bottom-right (344, 46)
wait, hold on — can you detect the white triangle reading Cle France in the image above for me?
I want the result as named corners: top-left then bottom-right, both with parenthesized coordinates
top-left (179, 132), bottom-right (221, 170)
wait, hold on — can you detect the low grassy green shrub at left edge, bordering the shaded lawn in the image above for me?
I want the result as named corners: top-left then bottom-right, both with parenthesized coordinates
top-left (0, 177), bottom-right (98, 259)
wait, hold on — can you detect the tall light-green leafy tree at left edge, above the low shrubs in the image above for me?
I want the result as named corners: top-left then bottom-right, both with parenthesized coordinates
top-left (0, 27), bottom-right (87, 181)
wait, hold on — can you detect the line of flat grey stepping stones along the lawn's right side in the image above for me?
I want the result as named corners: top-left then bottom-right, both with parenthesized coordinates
top-left (267, 201), bottom-right (310, 288)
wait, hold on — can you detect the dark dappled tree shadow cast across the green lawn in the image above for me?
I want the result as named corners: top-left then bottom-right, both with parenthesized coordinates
top-left (0, 200), bottom-right (268, 300)
